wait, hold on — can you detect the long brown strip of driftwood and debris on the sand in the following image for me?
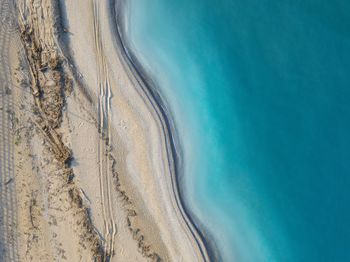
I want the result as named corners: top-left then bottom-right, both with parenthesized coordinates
top-left (19, 1), bottom-right (106, 261)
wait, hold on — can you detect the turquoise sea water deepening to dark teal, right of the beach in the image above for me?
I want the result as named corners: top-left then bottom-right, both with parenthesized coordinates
top-left (128, 0), bottom-right (350, 262)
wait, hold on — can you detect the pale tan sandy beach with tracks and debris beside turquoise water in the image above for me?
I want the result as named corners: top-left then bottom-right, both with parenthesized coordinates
top-left (0, 0), bottom-right (210, 261)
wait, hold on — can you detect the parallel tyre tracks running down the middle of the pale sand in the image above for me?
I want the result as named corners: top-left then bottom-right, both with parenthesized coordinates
top-left (92, 0), bottom-right (117, 261)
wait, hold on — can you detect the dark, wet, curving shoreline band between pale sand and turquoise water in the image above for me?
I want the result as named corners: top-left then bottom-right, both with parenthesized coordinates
top-left (109, 0), bottom-right (216, 261)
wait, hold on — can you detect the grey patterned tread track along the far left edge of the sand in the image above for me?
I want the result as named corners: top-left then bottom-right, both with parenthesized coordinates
top-left (0, 0), bottom-right (19, 262)
